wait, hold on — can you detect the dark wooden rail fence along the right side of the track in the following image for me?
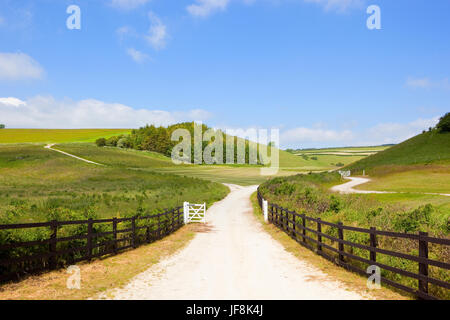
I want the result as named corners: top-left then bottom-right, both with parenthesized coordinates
top-left (257, 190), bottom-right (450, 299)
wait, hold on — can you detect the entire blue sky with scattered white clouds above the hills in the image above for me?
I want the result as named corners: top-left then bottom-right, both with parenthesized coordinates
top-left (0, 0), bottom-right (450, 148)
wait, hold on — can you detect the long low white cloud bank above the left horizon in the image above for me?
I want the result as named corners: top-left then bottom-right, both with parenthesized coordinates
top-left (0, 96), bottom-right (211, 129)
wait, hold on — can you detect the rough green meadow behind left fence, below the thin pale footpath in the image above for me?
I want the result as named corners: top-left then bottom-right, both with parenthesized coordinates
top-left (0, 145), bottom-right (228, 224)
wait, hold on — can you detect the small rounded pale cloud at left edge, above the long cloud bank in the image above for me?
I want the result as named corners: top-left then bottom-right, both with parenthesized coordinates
top-left (0, 52), bottom-right (44, 80)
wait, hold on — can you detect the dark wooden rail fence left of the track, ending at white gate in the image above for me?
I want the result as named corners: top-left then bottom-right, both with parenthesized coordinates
top-left (0, 207), bottom-right (184, 282)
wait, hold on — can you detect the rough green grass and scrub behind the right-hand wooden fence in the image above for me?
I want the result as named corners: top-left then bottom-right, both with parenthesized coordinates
top-left (260, 173), bottom-right (450, 299)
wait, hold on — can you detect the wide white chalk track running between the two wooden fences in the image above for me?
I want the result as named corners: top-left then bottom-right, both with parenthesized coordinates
top-left (96, 185), bottom-right (370, 300)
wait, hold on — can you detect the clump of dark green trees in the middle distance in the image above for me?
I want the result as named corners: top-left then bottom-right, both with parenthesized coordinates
top-left (95, 122), bottom-right (261, 164)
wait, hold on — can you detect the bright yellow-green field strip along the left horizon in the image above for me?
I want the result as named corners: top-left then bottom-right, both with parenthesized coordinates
top-left (0, 129), bottom-right (131, 143)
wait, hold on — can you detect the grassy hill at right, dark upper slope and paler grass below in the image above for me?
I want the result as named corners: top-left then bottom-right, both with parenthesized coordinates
top-left (346, 130), bottom-right (450, 194)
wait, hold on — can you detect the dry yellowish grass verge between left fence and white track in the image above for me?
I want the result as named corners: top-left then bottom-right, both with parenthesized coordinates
top-left (0, 225), bottom-right (199, 300)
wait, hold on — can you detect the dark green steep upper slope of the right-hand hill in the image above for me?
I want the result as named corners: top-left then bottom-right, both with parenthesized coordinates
top-left (346, 130), bottom-right (450, 174)
